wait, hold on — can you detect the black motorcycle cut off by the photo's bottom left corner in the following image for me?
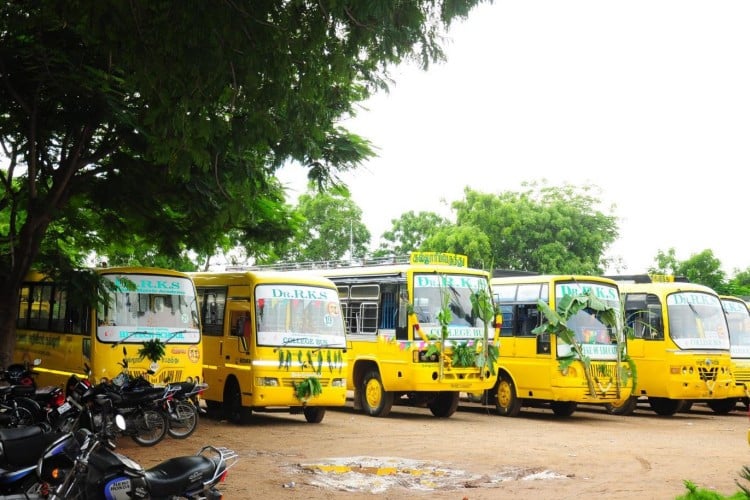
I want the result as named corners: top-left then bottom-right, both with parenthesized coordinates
top-left (0, 425), bottom-right (65, 499)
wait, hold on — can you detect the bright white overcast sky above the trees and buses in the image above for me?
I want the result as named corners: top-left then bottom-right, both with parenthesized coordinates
top-left (279, 0), bottom-right (750, 275)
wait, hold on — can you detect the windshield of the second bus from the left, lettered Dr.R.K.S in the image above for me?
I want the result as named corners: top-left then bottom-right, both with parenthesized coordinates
top-left (255, 284), bottom-right (346, 347)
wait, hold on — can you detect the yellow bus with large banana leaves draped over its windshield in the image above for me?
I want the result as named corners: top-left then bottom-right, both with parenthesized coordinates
top-left (475, 274), bottom-right (632, 417)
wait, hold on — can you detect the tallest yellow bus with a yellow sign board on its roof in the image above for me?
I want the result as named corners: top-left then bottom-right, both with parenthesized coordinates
top-left (290, 252), bottom-right (499, 418)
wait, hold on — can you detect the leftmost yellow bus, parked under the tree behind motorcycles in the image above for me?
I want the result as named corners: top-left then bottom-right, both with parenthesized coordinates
top-left (14, 267), bottom-right (203, 387)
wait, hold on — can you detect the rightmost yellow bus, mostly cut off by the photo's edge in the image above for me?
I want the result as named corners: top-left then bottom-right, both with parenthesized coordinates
top-left (720, 295), bottom-right (750, 411)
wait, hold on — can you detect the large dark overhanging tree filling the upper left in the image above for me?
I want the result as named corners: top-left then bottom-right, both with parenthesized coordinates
top-left (0, 0), bottom-right (488, 366)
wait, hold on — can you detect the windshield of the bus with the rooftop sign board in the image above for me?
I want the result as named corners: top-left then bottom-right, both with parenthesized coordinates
top-left (414, 274), bottom-right (489, 339)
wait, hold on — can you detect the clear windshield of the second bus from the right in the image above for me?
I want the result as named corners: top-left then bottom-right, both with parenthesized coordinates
top-left (667, 292), bottom-right (729, 349)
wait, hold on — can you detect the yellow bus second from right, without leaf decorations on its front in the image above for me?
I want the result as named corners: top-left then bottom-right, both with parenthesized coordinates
top-left (609, 281), bottom-right (735, 415)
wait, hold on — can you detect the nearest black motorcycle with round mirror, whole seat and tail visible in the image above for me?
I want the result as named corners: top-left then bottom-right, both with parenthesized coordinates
top-left (37, 407), bottom-right (239, 500)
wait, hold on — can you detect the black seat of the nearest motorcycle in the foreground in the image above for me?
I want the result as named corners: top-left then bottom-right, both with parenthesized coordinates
top-left (145, 455), bottom-right (217, 497)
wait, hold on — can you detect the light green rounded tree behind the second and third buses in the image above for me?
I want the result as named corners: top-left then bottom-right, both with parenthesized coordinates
top-left (274, 186), bottom-right (370, 262)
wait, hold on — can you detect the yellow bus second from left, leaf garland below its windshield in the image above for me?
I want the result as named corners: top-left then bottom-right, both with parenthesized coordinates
top-left (191, 271), bottom-right (346, 423)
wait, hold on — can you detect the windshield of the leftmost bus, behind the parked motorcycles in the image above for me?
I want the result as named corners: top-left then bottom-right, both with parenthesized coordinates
top-left (96, 274), bottom-right (200, 344)
